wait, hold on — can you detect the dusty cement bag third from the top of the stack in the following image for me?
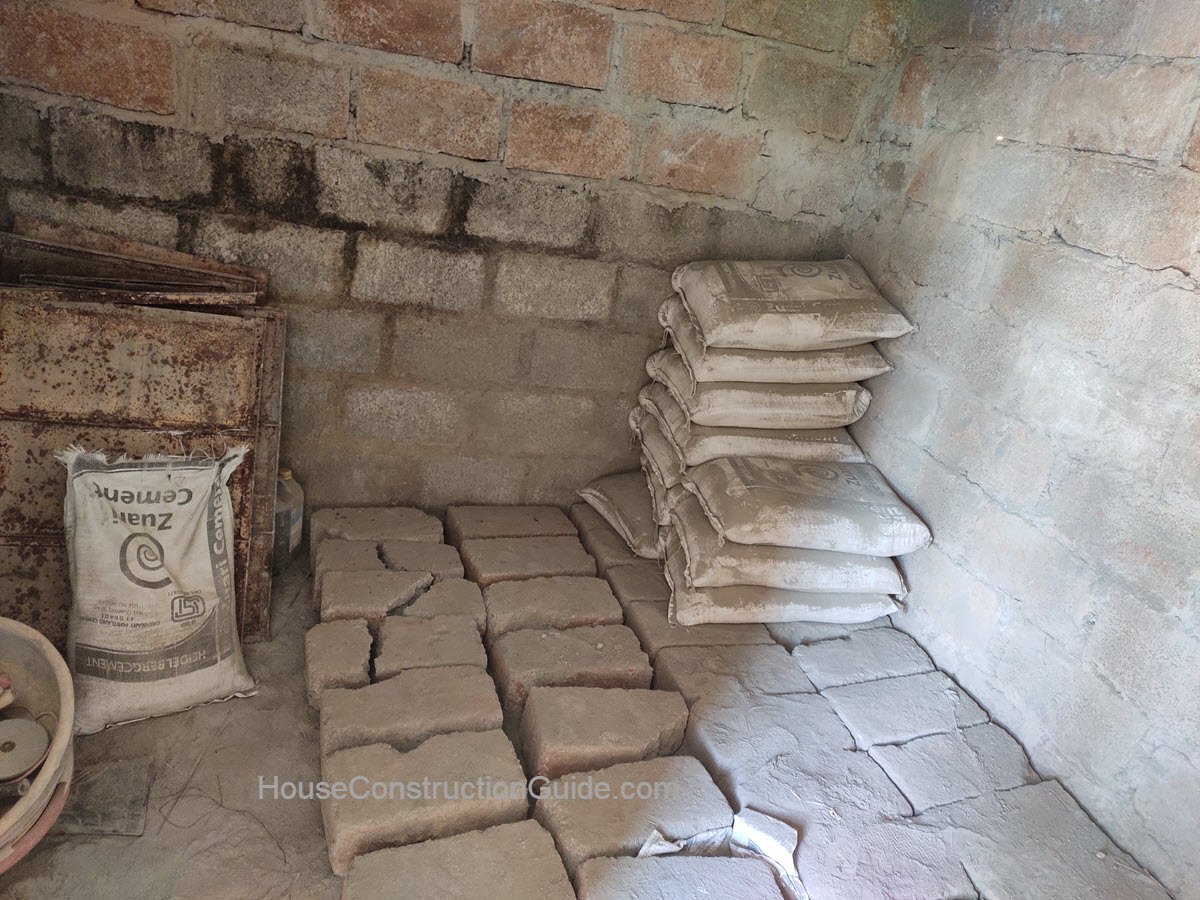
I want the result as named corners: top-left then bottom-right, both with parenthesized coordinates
top-left (646, 348), bottom-right (871, 430)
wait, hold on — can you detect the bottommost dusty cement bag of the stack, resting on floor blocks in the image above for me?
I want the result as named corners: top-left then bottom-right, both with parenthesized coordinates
top-left (664, 532), bottom-right (900, 625)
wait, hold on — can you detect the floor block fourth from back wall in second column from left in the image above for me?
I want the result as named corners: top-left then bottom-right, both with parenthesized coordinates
top-left (492, 625), bottom-right (654, 716)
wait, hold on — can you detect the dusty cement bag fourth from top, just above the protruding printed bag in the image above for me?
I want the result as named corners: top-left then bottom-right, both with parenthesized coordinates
top-left (637, 382), bottom-right (866, 466)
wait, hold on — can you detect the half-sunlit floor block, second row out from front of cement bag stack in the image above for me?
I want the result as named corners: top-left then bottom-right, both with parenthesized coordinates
top-left (654, 644), bottom-right (816, 706)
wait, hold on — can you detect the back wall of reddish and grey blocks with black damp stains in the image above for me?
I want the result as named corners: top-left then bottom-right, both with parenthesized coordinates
top-left (0, 0), bottom-right (898, 508)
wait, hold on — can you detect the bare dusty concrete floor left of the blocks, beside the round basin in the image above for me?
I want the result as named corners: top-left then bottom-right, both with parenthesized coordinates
top-left (0, 563), bottom-right (341, 900)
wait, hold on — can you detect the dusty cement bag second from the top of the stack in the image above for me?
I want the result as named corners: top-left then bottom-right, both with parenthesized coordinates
top-left (659, 294), bottom-right (893, 384)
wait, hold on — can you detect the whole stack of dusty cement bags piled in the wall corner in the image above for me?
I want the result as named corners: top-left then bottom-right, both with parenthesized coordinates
top-left (584, 259), bottom-right (930, 625)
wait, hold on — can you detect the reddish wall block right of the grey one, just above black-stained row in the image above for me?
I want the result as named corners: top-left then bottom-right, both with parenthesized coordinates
top-left (358, 68), bottom-right (500, 160)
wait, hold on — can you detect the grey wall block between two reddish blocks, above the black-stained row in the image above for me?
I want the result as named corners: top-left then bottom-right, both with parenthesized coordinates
top-left (193, 44), bottom-right (350, 138)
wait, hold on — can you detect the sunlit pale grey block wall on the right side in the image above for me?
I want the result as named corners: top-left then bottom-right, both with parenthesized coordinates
top-left (847, 0), bottom-right (1200, 900)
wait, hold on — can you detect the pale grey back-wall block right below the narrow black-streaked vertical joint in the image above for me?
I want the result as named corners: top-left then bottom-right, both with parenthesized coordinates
top-left (350, 236), bottom-right (484, 311)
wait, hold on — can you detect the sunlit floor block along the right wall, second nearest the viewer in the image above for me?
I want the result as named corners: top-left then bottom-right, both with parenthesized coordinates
top-left (869, 722), bottom-right (1042, 814)
